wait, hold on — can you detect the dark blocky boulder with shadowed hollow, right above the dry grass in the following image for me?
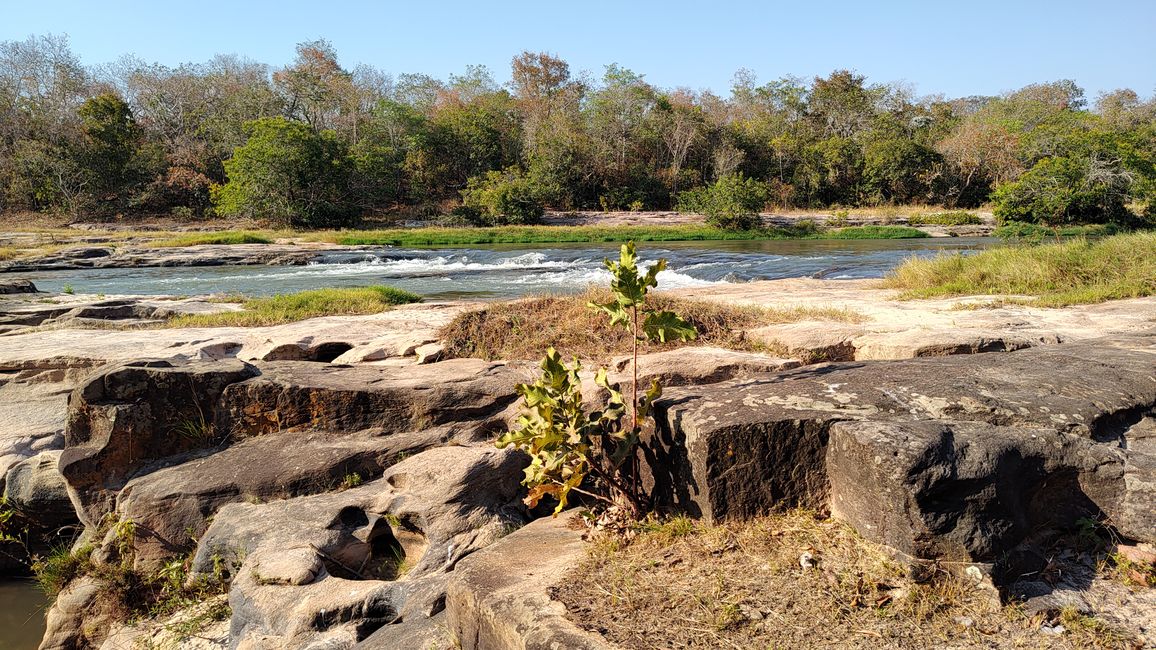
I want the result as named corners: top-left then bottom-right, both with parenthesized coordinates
top-left (827, 421), bottom-right (1124, 563)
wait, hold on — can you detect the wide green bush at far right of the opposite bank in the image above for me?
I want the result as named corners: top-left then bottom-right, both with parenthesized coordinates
top-left (992, 157), bottom-right (1131, 226)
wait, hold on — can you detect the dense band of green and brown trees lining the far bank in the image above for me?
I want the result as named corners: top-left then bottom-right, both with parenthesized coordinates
top-left (0, 36), bottom-right (1156, 227)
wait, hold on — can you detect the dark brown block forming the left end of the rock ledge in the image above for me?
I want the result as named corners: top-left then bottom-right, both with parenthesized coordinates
top-left (60, 360), bottom-right (257, 525)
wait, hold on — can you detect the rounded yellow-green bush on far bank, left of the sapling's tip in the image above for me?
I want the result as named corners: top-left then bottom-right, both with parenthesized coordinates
top-left (457, 168), bottom-right (546, 226)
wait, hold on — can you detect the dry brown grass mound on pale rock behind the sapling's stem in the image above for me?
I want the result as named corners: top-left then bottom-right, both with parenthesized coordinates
top-left (440, 289), bottom-right (864, 363)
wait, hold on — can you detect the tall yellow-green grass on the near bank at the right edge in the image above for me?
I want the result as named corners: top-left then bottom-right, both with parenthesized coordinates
top-left (884, 232), bottom-right (1156, 306)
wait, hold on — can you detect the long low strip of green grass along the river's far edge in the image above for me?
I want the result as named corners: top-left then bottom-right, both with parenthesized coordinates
top-left (333, 220), bottom-right (927, 246)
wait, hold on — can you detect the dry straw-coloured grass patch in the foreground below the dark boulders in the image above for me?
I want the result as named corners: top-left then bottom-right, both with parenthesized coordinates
top-left (555, 511), bottom-right (1134, 649)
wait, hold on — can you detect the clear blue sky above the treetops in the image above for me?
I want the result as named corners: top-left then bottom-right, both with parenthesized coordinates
top-left (0, 0), bottom-right (1156, 98)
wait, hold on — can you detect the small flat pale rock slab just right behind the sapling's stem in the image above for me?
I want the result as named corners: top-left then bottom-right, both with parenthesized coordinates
top-left (610, 347), bottom-right (801, 387)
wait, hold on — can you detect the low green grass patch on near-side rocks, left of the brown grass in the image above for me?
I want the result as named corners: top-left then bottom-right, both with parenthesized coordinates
top-left (166, 286), bottom-right (422, 327)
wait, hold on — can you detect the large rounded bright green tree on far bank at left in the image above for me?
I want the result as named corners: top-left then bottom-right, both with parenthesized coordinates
top-left (214, 117), bottom-right (356, 227)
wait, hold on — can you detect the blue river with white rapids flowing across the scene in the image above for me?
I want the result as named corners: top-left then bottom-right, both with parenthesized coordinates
top-left (15, 237), bottom-right (994, 298)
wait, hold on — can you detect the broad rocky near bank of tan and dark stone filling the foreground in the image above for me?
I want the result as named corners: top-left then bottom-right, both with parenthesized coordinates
top-left (0, 233), bottom-right (1156, 650)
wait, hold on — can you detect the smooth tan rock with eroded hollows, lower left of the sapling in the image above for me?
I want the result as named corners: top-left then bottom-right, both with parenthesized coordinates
top-left (193, 446), bottom-right (528, 648)
